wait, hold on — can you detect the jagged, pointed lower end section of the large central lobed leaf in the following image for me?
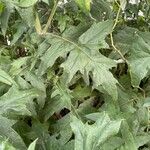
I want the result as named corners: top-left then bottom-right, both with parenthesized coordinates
top-left (61, 48), bottom-right (118, 100)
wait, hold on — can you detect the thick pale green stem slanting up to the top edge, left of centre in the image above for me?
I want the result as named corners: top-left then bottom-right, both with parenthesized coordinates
top-left (42, 0), bottom-right (58, 34)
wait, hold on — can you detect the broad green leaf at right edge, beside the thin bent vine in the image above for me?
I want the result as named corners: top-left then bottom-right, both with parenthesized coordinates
top-left (111, 27), bottom-right (150, 87)
